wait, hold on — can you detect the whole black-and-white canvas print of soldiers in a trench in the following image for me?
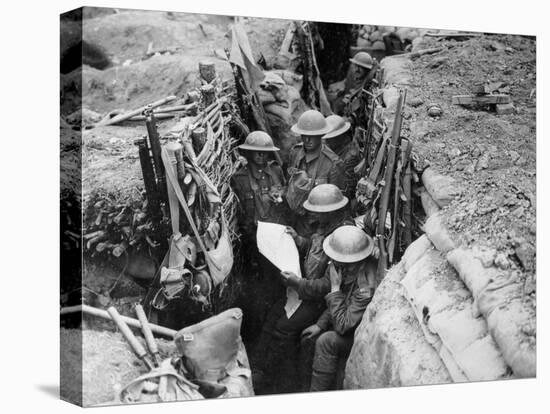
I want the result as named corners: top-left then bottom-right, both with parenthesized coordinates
top-left (56, 3), bottom-right (544, 411)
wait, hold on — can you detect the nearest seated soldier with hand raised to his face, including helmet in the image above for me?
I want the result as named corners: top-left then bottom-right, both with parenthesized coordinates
top-left (282, 226), bottom-right (376, 391)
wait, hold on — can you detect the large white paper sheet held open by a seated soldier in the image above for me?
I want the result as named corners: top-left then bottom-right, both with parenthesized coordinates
top-left (256, 221), bottom-right (302, 319)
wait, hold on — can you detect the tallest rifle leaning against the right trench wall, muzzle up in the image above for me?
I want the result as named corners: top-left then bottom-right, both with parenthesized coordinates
top-left (376, 89), bottom-right (407, 284)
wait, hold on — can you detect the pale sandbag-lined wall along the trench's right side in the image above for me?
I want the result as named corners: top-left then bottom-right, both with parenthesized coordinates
top-left (344, 42), bottom-right (536, 389)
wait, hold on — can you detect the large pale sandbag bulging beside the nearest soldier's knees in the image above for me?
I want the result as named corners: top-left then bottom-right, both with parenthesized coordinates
top-left (344, 260), bottom-right (453, 389)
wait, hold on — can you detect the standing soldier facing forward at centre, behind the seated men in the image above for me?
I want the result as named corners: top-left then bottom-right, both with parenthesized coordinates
top-left (287, 110), bottom-right (346, 237)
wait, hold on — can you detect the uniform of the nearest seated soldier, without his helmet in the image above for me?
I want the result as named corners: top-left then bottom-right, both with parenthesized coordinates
top-left (298, 258), bottom-right (376, 391)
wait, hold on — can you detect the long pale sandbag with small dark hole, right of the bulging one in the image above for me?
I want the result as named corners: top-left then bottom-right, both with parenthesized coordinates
top-left (401, 249), bottom-right (508, 382)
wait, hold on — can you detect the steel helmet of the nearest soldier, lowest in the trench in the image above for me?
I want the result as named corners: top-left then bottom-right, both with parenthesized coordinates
top-left (323, 225), bottom-right (374, 263)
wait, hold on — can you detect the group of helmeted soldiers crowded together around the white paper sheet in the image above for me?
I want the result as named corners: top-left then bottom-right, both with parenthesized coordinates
top-left (233, 51), bottom-right (376, 393)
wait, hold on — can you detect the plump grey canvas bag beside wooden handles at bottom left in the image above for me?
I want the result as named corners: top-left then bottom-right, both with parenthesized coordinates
top-left (174, 308), bottom-right (246, 382)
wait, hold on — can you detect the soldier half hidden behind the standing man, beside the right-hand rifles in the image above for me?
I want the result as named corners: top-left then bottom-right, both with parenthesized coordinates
top-left (323, 115), bottom-right (361, 199)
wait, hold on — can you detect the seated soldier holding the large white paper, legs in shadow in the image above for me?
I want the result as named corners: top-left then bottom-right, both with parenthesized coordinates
top-left (252, 184), bottom-right (353, 393)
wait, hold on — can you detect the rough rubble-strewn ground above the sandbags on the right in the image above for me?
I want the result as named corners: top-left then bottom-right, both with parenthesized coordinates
top-left (405, 35), bottom-right (536, 286)
